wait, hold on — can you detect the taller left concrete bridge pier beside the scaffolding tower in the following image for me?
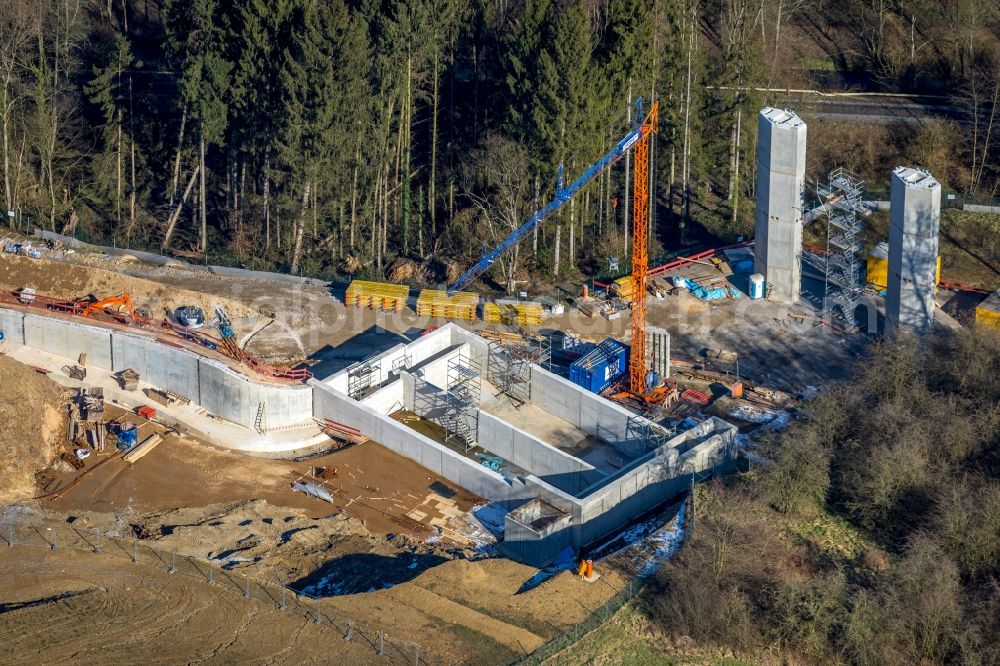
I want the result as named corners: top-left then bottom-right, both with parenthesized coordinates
top-left (754, 107), bottom-right (806, 303)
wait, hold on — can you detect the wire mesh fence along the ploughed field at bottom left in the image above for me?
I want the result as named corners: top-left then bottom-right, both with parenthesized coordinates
top-left (0, 520), bottom-right (462, 666)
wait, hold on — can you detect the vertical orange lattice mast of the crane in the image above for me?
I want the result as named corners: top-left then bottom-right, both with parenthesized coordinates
top-left (628, 100), bottom-right (660, 395)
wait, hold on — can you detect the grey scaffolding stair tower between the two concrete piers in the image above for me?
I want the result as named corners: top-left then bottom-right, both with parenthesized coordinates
top-left (816, 168), bottom-right (870, 323)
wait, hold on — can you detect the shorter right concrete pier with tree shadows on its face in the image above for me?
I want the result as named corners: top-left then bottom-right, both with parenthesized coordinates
top-left (885, 166), bottom-right (941, 334)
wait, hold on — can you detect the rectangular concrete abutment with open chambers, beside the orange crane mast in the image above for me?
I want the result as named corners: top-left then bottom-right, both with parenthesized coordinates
top-left (310, 324), bottom-right (737, 566)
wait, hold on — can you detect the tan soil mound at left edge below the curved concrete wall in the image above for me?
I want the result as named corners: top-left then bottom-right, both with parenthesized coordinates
top-left (0, 356), bottom-right (67, 502)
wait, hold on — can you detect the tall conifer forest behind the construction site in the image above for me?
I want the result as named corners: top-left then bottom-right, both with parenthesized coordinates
top-left (0, 0), bottom-right (1000, 284)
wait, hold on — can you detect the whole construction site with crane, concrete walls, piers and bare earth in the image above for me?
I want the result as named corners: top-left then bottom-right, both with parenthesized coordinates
top-left (0, 103), bottom-right (1000, 663)
